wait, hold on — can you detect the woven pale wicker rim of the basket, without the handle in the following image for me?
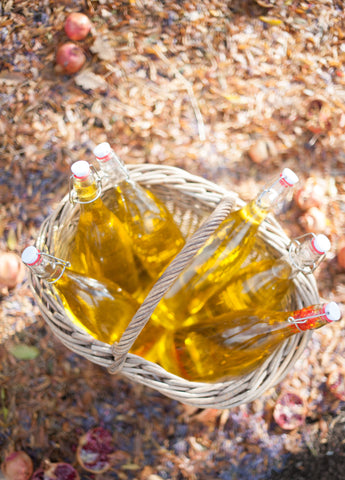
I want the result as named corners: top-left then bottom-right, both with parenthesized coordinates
top-left (29, 164), bottom-right (319, 408)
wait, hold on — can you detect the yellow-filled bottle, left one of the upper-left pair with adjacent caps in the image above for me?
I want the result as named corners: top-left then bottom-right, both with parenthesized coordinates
top-left (66, 160), bottom-right (138, 293)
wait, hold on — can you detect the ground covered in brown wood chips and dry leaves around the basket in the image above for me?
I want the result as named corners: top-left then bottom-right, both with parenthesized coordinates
top-left (0, 0), bottom-right (345, 480)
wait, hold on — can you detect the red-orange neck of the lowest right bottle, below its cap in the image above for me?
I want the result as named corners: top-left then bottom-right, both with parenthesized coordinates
top-left (288, 304), bottom-right (331, 333)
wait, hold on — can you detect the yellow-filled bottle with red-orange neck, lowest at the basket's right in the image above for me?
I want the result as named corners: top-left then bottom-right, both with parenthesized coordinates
top-left (158, 302), bottom-right (341, 382)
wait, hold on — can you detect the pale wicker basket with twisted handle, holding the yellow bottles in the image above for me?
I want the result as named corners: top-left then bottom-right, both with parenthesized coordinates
top-left (29, 164), bottom-right (320, 409)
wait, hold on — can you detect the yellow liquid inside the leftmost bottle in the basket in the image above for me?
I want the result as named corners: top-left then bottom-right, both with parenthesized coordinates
top-left (54, 269), bottom-right (163, 361)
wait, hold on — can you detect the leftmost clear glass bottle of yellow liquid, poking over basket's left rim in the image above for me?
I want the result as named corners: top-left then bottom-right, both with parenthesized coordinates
top-left (22, 246), bottom-right (162, 361)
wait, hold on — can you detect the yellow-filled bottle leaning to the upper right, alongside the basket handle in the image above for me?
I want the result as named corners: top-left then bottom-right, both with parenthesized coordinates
top-left (152, 168), bottom-right (298, 329)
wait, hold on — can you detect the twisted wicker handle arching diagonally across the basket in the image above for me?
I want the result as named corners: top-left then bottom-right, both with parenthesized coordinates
top-left (108, 195), bottom-right (236, 374)
